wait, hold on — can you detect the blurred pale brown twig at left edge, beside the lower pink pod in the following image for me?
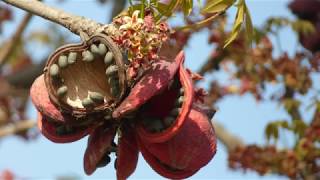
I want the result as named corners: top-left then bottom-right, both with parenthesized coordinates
top-left (0, 120), bottom-right (37, 139)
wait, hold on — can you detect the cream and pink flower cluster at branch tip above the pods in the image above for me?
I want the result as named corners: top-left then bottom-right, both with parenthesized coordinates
top-left (112, 11), bottom-right (170, 77)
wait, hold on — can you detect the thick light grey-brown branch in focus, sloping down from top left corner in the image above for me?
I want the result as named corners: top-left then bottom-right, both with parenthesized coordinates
top-left (2, 0), bottom-right (109, 36)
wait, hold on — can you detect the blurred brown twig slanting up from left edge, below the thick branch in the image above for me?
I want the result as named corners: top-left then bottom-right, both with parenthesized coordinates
top-left (0, 13), bottom-right (32, 69)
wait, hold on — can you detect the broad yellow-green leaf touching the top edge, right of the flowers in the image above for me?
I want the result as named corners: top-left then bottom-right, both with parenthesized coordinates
top-left (201, 0), bottom-right (235, 13)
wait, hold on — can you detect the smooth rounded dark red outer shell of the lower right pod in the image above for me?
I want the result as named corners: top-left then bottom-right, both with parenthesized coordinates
top-left (137, 107), bottom-right (216, 179)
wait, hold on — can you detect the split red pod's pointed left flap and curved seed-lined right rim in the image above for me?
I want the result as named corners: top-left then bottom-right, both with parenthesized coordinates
top-left (113, 52), bottom-right (194, 143)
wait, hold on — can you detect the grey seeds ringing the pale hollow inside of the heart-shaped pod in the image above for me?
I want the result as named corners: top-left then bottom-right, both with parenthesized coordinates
top-left (49, 42), bottom-right (120, 109)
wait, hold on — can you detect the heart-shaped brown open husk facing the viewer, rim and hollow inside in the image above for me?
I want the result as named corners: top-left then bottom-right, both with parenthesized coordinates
top-left (44, 34), bottom-right (126, 117)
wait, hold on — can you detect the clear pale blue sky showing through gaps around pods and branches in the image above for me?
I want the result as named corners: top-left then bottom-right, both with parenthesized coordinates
top-left (0, 0), bottom-right (296, 179)
